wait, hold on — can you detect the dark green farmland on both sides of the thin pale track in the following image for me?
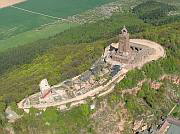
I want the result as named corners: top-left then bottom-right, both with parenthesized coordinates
top-left (0, 0), bottom-right (115, 40)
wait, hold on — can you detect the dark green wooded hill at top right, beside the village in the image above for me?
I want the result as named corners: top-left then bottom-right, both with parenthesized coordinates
top-left (133, 0), bottom-right (180, 25)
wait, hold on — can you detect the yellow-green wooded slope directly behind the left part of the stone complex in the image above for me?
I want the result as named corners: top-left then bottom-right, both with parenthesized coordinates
top-left (0, 43), bottom-right (103, 101)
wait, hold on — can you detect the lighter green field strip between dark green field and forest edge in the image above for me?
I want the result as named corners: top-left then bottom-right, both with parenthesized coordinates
top-left (0, 23), bottom-right (78, 52)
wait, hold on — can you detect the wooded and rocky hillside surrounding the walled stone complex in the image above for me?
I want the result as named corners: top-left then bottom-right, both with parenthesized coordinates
top-left (0, 0), bottom-right (180, 134)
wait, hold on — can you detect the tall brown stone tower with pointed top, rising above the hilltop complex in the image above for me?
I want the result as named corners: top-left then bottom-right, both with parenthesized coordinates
top-left (118, 26), bottom-right (131, 55)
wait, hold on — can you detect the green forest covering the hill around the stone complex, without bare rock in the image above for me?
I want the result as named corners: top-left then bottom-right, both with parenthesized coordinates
top-left (0, 0), bottom-right (180, 134)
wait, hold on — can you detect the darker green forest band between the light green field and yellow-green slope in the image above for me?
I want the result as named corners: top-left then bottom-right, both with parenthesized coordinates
top-left (0, 14), bottom-right (145, 74)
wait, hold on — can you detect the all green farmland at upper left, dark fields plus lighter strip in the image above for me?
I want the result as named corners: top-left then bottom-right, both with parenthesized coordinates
top-left (0, 0), bottom-right (116, 52)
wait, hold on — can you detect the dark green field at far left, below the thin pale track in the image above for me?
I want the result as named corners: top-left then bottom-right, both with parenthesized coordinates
top-left (0, 7), bottom-right (55, 40)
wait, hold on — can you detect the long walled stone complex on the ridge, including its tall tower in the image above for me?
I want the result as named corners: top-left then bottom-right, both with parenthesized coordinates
top-left (18, 27), bottom-right (165, 110)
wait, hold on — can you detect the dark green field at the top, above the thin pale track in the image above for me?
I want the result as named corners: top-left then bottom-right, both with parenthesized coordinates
top-left (18, 0), bottom-right (116, 18)
